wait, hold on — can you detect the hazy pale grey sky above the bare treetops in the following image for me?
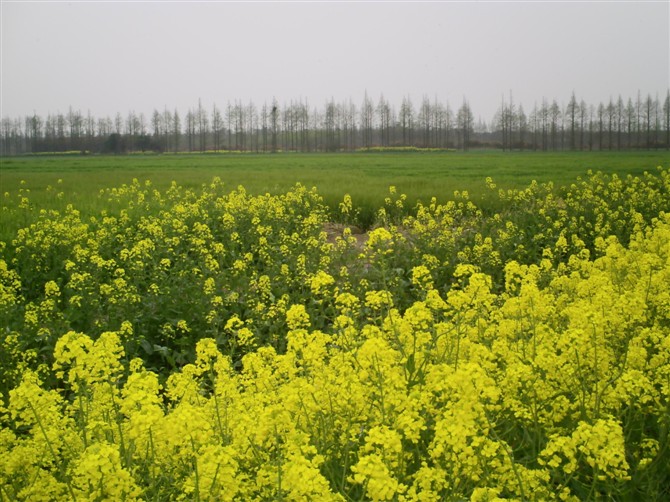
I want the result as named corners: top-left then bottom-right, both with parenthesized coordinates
top-left (0, 0), bottom-right (670, 121)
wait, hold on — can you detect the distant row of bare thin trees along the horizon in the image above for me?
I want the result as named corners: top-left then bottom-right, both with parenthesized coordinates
top-left (0, 89), bottom-right (670, 155)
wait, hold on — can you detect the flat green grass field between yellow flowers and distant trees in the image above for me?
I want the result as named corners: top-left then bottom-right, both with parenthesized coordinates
top-left (0, 151), bottom-right (670, 228)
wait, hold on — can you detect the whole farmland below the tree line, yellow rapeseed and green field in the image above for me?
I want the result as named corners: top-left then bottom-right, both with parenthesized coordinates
top-left (0, 152), bottom-right (670, 501)
